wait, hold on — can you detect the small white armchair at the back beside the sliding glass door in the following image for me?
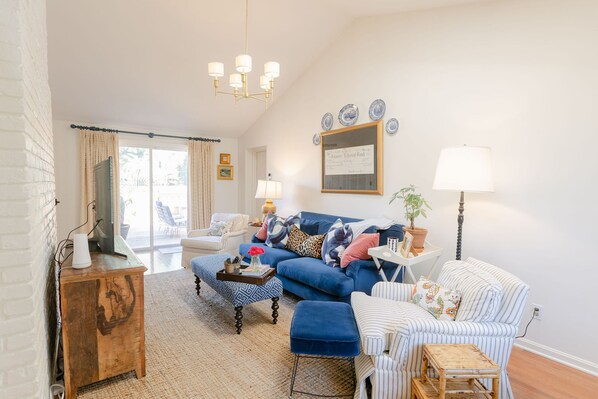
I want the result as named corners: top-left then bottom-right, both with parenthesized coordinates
top-left (181, 213), bottom-right (249, 267)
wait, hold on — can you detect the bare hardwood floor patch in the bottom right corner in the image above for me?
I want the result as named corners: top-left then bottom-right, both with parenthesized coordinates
top-left (507, 347), bottom-right (598, 399)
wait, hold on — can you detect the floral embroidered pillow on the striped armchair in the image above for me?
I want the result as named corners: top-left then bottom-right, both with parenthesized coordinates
top-left (411, 277), bottom-right (461, 321)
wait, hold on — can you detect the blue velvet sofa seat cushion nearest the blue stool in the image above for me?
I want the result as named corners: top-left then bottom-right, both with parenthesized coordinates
top-left (276, 258), bottom-right (354, 297)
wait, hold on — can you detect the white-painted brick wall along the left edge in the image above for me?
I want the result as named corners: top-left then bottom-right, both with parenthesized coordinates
top-left (0, 0), bottom-right (56, 398)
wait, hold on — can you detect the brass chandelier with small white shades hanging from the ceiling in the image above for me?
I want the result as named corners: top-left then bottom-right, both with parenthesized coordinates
top-left (208, 0), bottom-right (280, 104)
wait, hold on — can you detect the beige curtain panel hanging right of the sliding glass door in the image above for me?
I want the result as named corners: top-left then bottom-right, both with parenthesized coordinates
top-left (187, 140), bottom-right (213, 230)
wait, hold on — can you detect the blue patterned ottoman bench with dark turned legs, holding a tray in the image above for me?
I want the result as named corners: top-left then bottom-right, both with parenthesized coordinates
top-left (191, 253), bottom-right (282, 334)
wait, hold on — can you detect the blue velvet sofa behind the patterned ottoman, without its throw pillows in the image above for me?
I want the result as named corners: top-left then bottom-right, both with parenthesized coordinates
top-left (239, 211), bottom-right (403, 302)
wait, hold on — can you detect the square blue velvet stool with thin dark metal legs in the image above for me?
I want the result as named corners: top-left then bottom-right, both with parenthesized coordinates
top-left (289, 300), bottom-right (360, 398)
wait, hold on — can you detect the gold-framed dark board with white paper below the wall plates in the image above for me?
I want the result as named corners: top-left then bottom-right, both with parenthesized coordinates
top-left (321, 120), bottom-right (384, 195)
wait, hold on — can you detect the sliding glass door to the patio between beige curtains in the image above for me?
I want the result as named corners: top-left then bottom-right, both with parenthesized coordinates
top-left (120, 143), bottom-right (187, 250)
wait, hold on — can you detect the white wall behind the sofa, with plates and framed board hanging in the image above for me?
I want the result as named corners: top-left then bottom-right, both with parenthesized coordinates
top-left (239, 0), bottom-right (598, 372)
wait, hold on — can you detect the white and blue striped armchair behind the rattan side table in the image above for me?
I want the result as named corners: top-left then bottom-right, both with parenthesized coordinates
top-left (351, 258), bottom-right (529, 399)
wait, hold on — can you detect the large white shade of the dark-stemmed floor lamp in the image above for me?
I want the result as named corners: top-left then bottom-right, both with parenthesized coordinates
top-left (432, 146), bottom-right (494, 192)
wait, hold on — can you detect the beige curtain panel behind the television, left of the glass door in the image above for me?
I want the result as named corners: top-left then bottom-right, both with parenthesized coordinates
top-left (79, 130), bottom-right (120, 234)
